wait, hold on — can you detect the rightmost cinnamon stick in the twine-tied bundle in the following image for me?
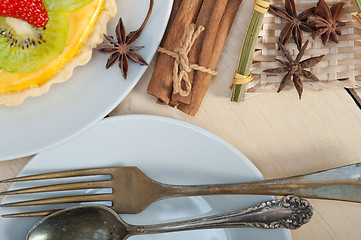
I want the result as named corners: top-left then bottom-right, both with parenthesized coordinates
top-left (178, 0), bottom-right (242, 116)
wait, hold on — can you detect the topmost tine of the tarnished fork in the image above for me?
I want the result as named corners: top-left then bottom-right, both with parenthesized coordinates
top-left (0, 168), bottom-right (113, 183)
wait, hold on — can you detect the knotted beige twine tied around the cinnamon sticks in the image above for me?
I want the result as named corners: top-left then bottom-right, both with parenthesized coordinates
top-left (158, 24), bottom-right (218, 97)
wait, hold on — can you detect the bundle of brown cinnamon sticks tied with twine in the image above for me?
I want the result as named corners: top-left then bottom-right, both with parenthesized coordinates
top-left (148, 0), bottom-right (242, 116)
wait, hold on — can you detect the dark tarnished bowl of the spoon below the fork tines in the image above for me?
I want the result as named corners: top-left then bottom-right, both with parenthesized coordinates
top-left (26, 206), bottom-right (128, 240)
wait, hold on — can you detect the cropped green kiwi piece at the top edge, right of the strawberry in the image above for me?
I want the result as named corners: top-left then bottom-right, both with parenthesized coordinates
top-left (43, 0), bottom-right (93, 12)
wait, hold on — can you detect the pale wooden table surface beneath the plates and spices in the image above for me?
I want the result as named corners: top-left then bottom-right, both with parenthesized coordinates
top-left (0, 0), bottom-right (361, 240)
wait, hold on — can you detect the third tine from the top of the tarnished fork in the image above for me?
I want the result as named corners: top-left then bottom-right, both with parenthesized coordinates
top-left (0, 194), bottom-right (113, 207)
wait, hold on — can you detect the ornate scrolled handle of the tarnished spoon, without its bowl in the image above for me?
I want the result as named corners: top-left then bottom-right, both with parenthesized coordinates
top-left (127, 195), bottom-right (313, 235)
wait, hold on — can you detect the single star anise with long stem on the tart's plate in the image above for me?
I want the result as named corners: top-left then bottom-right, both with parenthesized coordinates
top-left (98, 0), bottom-right (154, 79)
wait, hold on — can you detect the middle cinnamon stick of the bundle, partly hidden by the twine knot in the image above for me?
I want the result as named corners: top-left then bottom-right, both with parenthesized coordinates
top-left (172, 0), bottom-right (217, 105)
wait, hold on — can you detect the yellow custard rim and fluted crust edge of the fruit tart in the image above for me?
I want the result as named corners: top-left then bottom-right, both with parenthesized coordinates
top-left (0, 0), bottom-right (116, 106)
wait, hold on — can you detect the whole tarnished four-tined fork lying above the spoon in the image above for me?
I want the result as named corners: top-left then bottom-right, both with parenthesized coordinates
top-left (0, 163), bottom-right (361, 217)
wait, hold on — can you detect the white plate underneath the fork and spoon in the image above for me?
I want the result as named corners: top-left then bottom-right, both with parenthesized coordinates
top-left (0, 115), bottom-right (291, 240)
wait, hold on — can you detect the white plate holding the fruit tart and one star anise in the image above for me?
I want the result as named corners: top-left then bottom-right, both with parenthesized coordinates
top-left (0, 0), bottom-right (173, 161)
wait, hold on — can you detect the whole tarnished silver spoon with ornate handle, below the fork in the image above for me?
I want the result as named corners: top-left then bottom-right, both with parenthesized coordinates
top-left (26, 195), bottom-right (313, 240)
